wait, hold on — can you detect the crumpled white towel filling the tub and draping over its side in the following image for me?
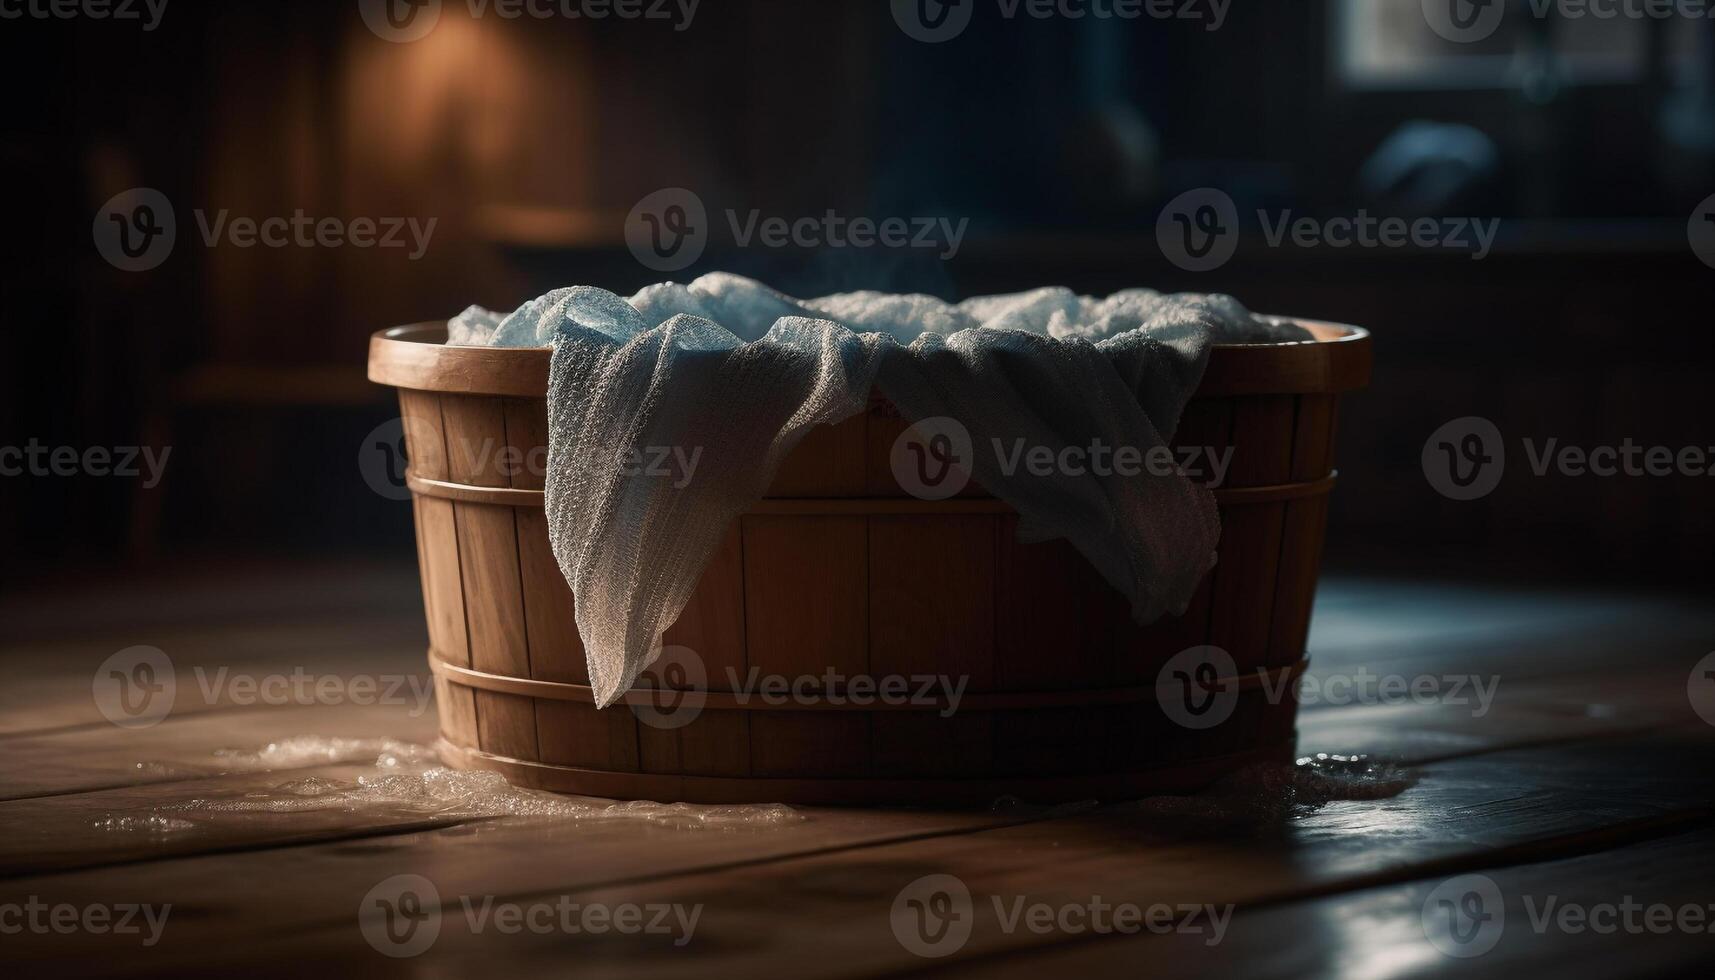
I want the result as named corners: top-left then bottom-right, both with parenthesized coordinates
top-left (463, 273), bottom-right (1309, 707)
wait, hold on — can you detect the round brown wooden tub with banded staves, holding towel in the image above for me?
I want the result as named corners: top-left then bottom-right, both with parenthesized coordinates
top-left (369, 321), bottom-right (1370, 803)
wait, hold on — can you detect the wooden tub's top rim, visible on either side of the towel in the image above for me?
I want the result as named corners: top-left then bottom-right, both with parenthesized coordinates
top-left (369, 316), bottom-right (1372, 398)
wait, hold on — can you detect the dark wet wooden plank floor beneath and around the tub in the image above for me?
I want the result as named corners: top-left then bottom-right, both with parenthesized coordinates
top-left (0, 568), bottom-right (1715, 978)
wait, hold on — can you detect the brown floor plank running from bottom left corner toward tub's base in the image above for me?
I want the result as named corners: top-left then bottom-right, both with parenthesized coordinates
top-left (0, 808), bottom-right (1015, 975)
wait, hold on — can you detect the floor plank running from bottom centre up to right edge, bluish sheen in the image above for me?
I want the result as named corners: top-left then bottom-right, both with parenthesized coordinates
top-left (326, 740), bottom-right (1715, 977)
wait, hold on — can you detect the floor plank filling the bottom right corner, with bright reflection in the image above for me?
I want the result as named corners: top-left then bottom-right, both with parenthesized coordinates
top-left (928, 826), bottom-right (1715, 980)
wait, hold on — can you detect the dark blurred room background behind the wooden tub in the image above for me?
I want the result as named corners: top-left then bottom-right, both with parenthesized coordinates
top-left (0, 0), bottom-right (1715, 587)
